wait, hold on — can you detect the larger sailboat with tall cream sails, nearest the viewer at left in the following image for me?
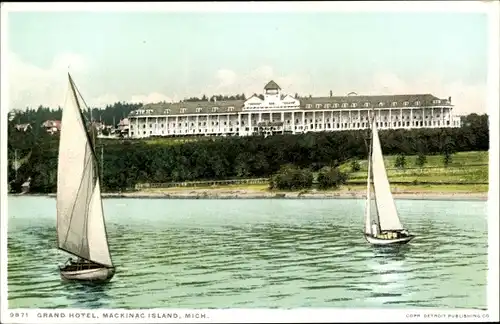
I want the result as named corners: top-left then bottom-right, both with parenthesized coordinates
top-left (57, 73), bottom-right (115, 282)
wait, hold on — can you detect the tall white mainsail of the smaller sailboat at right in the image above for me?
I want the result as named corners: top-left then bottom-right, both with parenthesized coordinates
top-left (372, 122), bottom-right (403, 231)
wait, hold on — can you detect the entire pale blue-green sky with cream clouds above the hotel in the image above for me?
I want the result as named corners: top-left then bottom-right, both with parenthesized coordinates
top-left (1, 2), bottom-right (488, 114)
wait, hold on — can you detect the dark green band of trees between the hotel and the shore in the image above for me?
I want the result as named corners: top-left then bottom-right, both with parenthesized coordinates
top-left (8, 114), bottom-right (489, 192)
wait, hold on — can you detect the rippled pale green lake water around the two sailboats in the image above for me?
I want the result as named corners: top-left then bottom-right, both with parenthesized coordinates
top-left (4, 197), bottom-right (487, 308)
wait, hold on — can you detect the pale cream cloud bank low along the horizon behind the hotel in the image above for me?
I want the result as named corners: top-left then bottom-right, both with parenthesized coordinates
top-left (7, 52), bottom-right (487, 114)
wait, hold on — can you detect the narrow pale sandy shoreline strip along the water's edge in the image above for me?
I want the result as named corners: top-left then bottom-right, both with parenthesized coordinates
top-left (8, 189), bottom-right (488, 201)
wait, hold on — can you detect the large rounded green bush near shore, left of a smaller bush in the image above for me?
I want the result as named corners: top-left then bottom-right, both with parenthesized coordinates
top-left (269, 165), bottom-right (313, 190)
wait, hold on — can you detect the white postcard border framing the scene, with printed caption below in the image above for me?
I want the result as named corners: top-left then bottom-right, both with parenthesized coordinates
top-left (0, 1), bottom-right (500, 323)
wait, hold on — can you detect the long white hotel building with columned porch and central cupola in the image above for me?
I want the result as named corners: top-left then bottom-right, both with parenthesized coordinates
top-left (129, 81), bottom-right (460, 138)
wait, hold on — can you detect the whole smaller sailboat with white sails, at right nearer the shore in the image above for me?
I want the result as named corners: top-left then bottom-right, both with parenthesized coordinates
top-left (364, 112), bottom-right (415, 245)
